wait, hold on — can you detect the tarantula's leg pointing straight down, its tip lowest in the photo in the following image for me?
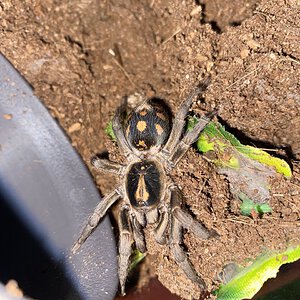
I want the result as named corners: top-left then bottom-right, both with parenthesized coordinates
top-left (118, 206), bottom-right (132, 295)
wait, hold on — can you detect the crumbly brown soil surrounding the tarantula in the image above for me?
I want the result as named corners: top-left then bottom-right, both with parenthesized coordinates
top-left (0, 0), bottom-right (300, 299)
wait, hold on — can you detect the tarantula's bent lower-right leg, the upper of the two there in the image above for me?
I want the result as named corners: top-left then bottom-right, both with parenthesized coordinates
top-left (171, 186), bottom-right (214, 240)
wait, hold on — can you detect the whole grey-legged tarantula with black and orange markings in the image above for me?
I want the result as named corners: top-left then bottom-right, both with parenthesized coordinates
top-left (72, 80), bottom-right (215, 295)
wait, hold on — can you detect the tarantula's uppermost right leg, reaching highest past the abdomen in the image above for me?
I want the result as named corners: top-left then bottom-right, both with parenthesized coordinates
top-left (163, 78), bottom-right (210, 156)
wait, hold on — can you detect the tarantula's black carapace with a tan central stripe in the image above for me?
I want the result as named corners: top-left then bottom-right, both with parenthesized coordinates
top-left (126, 161), bottom-right (162, 208)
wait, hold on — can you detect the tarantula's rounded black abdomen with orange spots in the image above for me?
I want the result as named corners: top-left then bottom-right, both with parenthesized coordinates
top-left (125, 99), bottom-right (170, 150)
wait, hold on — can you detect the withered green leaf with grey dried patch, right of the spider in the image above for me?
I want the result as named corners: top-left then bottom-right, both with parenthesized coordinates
top-left (188, 117), bottom-right (292, 209)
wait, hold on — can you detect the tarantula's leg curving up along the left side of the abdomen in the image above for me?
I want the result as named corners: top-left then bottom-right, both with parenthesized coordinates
top-left (112, 104), bottom-right (132, 157)
